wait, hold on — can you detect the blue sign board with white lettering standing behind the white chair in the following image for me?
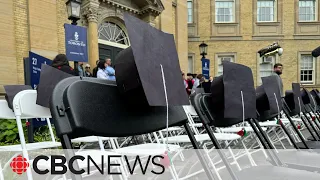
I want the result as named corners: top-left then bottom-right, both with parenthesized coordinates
top-left (29, 51), bottom-right (52, 127)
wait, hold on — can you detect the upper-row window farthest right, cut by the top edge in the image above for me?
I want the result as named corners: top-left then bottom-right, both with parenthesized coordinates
top-left (299, 0), bottom-right (316, 21)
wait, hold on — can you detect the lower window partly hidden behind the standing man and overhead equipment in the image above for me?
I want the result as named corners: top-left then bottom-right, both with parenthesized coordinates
top-left (258, 55), bottom-right (276, 84)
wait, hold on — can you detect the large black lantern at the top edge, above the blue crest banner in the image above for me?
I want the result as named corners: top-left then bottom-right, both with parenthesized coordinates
top-left (66, 0), bottom-right (81, 25)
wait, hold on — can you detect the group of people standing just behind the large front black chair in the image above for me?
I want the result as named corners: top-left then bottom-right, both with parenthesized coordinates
top-left (51, 54), bottom-right (116, 81)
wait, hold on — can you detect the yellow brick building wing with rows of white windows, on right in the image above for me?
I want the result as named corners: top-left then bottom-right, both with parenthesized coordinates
top-left (187, 0), bottom-right (320, 89)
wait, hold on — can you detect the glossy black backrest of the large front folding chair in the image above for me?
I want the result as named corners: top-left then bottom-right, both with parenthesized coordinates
top-left (51, 78), bottom-right (187, 138)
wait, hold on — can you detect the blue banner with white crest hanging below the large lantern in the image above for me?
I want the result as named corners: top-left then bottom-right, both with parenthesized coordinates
top-left (64, 24), bottom-right (88, 62)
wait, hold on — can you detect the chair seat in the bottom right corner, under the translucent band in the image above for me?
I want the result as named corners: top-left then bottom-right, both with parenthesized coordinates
top-left (235, 165), bottom-right (320, 180)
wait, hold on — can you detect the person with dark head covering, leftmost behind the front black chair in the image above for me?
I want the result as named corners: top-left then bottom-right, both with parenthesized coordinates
top-left (51, 54), bottom-right (78, 76)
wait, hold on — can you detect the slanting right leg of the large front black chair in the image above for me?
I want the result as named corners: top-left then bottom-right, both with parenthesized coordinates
top-left (184, 122), bottom-right (216, 180)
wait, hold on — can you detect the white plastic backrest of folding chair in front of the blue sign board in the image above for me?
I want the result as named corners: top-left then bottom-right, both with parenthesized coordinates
top-left (13, 90), bottom-right (51, 119)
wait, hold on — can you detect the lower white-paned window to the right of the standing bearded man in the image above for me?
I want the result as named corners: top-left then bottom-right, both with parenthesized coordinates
top-left (300, 55), bottom-right (315, 84)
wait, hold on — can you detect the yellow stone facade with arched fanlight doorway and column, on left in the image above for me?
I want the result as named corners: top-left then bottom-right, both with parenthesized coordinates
top-left (0, 0), bottom-right (188, 94)
